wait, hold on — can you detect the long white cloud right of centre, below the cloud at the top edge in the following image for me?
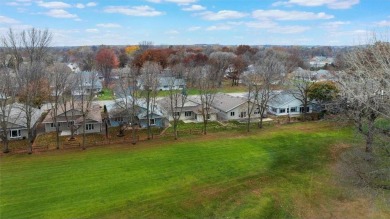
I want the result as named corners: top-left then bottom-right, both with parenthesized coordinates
top-left (252, 10), bottom-right (334, 20)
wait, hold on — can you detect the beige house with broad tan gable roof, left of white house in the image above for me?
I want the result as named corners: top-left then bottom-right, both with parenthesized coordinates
top-left (190, 93), bottom-right (260, 120)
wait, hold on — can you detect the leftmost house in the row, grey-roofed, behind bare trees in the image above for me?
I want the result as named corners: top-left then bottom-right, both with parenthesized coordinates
top-left (0, 103), bottom-right (42, 139)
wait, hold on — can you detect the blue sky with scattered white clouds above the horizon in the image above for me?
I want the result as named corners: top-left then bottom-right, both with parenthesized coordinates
top-left (0, 0), bottom-right (390, 46)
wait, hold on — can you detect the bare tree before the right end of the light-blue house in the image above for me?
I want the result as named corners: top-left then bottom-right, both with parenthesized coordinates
top-left (140, 62), bottom-right (161, 139)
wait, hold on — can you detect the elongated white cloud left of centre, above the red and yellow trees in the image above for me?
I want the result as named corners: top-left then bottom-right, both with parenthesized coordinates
top-left (104, 5), bottom-right (164, 17)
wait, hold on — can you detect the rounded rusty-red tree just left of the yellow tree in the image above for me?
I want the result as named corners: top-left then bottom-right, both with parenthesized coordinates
top-left (96, 47), bottom-right (119, 87)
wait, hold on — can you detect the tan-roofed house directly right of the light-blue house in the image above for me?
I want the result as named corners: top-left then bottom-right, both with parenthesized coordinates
top-left (157, 96), bottom-right (218, 122)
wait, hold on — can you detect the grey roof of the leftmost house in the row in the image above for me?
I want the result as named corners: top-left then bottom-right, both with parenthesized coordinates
top-left (1, 103), bottom-right (42, 128)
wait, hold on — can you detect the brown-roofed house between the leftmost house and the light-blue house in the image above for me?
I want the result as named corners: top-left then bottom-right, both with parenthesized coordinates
top-left (42, 103), bottom-right (102, 135)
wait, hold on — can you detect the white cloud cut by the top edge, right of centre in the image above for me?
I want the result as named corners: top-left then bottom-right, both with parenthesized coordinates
top-left (272, 0), bottom-right (359, 9)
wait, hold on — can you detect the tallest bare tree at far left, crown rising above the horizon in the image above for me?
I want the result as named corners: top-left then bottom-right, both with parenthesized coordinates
top-left (2, 28), bottom-right (52, 154)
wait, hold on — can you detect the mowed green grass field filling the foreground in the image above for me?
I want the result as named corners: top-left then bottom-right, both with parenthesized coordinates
top-left (0, 122), bottom-right (353, 218)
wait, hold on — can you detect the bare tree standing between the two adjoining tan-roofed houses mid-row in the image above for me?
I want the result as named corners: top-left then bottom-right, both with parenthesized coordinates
top-left (195, 66), bottom-right (218, 135)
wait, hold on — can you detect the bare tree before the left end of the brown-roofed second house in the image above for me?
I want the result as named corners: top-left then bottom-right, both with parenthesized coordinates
top-left (48, 63), bottom-right (71, 149)
